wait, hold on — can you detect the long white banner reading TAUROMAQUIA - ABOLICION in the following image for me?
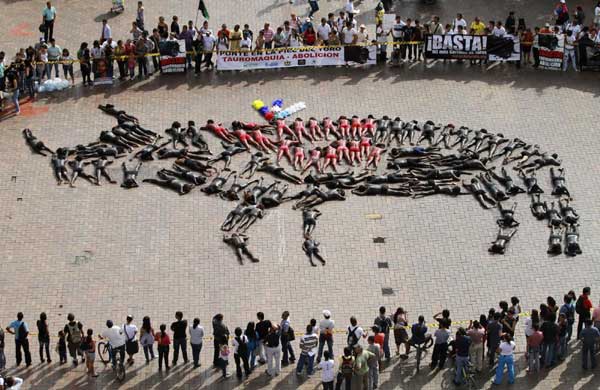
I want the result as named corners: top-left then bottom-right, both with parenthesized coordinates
top-left (217, 45), bottom-right (376, 70)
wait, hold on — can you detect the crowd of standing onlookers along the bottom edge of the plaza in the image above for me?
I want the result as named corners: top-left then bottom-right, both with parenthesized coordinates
top-left (0, 287), bottom-right (600, 390)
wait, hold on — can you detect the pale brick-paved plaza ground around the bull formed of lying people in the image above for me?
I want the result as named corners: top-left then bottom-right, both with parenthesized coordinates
top-left (0, 0), bottom-right (600, 390)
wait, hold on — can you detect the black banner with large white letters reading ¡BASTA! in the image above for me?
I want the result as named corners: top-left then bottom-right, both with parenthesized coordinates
top-left (425, 34), bottom-right (488, 60)
